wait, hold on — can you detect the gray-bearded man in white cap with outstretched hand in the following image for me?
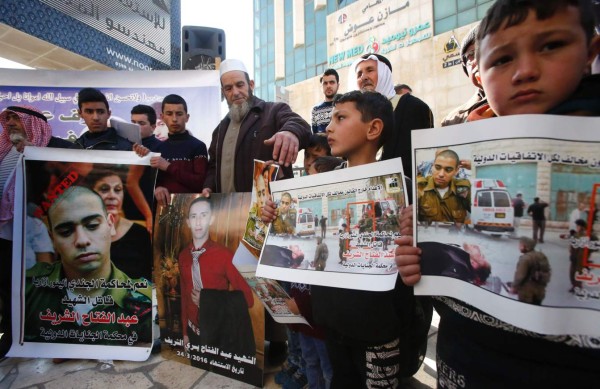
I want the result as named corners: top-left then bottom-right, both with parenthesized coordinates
top-left (202, 59), bottom-right (311, 196)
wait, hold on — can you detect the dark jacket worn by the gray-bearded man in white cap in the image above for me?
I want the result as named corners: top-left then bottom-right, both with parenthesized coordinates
top-left (204, 97), bottom-right (311, 192)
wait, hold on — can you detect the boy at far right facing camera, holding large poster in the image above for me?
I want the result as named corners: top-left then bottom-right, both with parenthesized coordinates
top-left (396, 0), bottom-right (600, 388)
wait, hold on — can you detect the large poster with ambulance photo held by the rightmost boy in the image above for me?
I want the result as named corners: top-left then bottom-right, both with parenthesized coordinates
top-left (413, 116), bottom-right (600, 334)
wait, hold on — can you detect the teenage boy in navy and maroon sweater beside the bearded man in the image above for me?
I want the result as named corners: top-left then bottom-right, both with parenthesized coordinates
top-left (134, 95), bottom-right (208, 207)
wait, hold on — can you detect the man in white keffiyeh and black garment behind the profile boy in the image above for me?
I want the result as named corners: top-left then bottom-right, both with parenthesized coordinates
top-left (349, 54), bottom-right (433, 176)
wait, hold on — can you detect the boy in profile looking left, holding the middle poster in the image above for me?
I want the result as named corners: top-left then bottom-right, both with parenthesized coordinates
top-left (263, 91), bottom-right (425, 388)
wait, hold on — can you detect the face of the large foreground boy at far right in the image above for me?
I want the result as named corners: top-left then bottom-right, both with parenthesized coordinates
top-left (479, 6), bottom-right (591, 116)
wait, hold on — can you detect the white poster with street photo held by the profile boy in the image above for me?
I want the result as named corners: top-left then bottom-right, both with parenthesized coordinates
top-left (256, 159), bottom-right (407, 290)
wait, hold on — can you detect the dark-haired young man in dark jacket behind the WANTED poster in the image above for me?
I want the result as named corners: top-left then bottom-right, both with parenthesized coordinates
top-left (75, 88), bottom-right (133, 151)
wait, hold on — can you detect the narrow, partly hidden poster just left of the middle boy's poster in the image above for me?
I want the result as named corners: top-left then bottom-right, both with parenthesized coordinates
top-left (244, 159), bottom-right (279, 253)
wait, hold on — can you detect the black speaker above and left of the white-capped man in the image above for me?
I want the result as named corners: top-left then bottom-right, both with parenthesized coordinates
top-left (181, 26), bottom-right (225, 70)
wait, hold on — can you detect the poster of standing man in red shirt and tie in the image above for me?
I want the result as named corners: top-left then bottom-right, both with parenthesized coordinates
top-left (154, 193), bottom-right (264, 386)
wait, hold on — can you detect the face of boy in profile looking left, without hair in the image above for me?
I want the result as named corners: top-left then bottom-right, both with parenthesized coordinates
top-left (327, 101), bottom-right (370, 158)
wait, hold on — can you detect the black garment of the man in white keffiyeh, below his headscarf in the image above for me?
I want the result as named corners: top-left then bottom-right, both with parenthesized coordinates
top-left (381, 93), bottom-right (433, 177)
